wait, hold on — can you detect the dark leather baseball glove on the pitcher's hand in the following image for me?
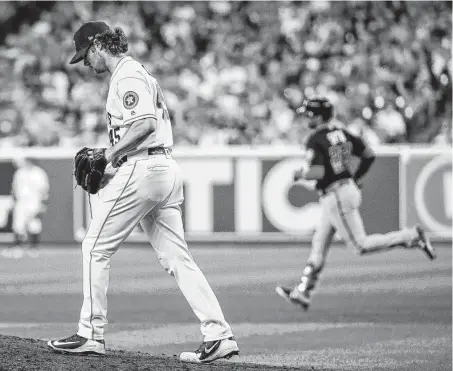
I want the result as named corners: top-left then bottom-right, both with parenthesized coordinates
top-left (74, 147), bottom-right (107, 194)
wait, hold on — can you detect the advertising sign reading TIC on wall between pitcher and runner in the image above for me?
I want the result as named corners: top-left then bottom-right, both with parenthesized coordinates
top-left (74, 155), bottom-right (399, 241)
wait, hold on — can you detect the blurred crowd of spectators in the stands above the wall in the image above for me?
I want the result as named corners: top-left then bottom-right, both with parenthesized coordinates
top-left (0, 1), bottom-right (452, 147)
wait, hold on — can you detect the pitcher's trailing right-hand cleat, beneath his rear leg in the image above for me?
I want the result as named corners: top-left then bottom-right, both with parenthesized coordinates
top-left (179, 336), bottom-right (239, 363)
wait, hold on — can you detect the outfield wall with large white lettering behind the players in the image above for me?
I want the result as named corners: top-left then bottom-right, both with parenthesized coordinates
top-left (0, 146), bottom-right (453, 243)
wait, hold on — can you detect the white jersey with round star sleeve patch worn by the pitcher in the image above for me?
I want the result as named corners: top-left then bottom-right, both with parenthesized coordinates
top-left (106, 57), bottom-right (173, 153)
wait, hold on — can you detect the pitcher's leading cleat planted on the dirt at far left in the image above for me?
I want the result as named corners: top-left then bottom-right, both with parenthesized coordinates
top-left (47, 334), bottom-right (105, 355)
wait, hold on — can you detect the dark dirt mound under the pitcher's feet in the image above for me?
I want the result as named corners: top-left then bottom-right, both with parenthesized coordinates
top-left (0, 335), bottom-right (300, 371)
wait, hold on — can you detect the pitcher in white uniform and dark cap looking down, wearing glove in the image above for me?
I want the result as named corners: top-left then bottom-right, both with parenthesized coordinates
top-left (48, 22), bottom-right (239, 363)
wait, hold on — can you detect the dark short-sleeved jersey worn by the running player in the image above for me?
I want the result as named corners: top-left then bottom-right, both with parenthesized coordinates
top-left (307, 125), bottom-right (366, 189)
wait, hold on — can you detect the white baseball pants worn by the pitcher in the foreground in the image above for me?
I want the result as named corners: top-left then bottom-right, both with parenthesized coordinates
top-left (77, 154), bottom-right (232, 341)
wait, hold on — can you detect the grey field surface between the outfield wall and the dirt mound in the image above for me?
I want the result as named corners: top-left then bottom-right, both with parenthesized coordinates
top-left (0, 244), bottom-right (452, 371)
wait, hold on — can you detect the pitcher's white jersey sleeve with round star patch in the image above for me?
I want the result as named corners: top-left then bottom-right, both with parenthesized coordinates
top-left (118, 77), bottom-right (157, 125)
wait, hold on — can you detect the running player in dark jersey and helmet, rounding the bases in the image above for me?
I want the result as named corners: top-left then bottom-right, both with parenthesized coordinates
top-left (276, 98), bottom-right (436, 310)
